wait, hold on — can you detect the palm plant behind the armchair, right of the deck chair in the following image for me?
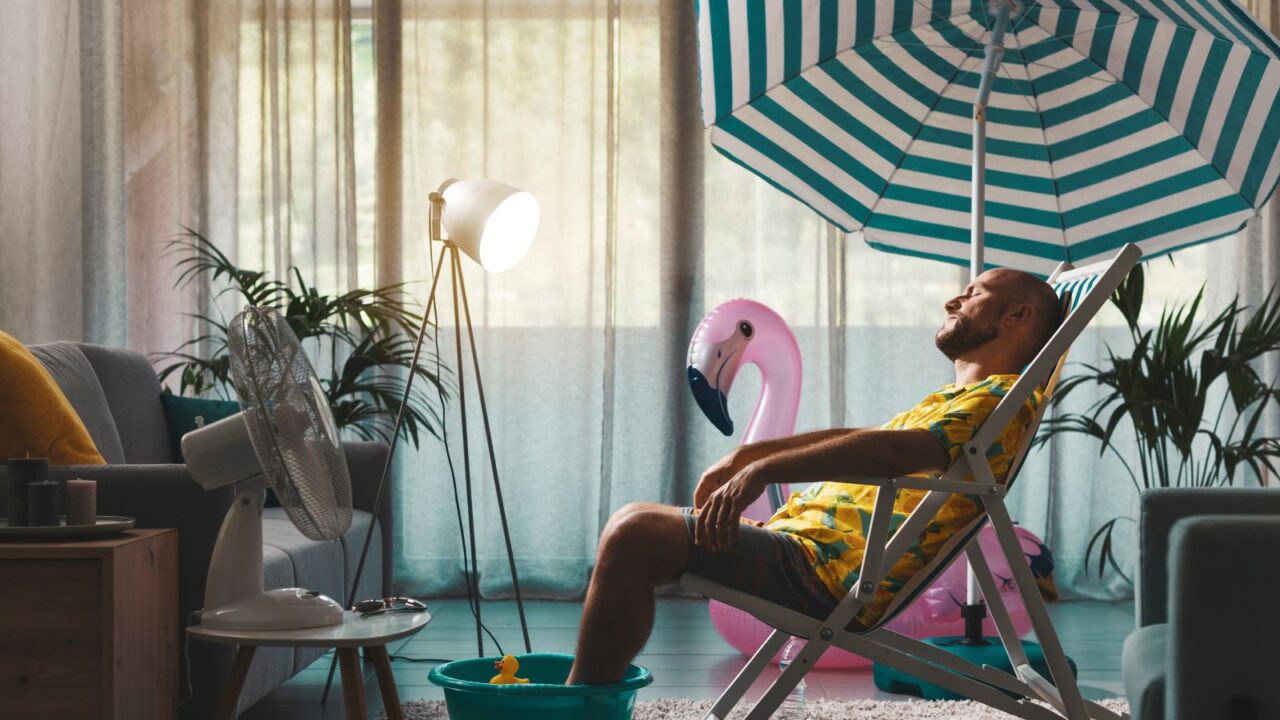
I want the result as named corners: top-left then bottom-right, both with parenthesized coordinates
top-left (1036, 265), bottom-right (1280, 580)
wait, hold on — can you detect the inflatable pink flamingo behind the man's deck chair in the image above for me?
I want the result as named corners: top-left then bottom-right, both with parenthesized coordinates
top-left (687, 300), bottom-right (1052, 667)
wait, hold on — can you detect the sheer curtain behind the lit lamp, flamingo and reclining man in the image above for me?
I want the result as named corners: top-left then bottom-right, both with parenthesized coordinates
top-left (397, 0), bottom-right (1276, 598)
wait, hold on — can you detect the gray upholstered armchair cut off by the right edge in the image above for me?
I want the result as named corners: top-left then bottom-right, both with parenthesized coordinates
top-left (1120, 488), bottom-right (1280, 720)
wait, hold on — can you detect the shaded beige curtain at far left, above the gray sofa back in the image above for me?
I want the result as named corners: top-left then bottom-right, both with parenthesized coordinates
top-left (0, 0), bottom-right (195, 351)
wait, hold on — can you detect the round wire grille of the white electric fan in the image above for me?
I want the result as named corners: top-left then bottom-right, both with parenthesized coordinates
top-left (227, 306), bottom-right (351, 539)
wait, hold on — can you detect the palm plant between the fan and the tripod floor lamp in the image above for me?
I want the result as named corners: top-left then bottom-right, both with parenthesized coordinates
top-left (157, 227), bottom-right (445, 447)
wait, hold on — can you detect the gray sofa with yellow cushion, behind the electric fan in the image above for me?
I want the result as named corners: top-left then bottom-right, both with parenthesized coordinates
top-left (17, 342), bottom-right (392, 717)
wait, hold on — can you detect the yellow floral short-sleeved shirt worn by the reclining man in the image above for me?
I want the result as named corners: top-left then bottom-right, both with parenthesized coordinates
top-left (765, 375), bottom-right (1042, 628)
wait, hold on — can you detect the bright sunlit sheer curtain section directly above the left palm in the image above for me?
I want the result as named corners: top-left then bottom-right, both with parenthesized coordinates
top-left (202, 0), bottom-right (376, 292)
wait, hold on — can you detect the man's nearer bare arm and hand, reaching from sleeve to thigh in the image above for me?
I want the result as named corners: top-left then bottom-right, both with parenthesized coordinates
top-left (694, 428), bottom-right (951, 550)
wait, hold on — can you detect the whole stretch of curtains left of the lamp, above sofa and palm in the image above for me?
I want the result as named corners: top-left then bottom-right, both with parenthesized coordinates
top-left (0, 0), bottom-right (375, 352)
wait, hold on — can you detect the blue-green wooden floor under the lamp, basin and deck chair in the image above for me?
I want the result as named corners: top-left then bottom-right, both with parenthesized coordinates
top-left (241, 598), bottom-right (1134, 720)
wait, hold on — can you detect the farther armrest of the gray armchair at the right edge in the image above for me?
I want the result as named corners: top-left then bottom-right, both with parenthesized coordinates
top-left (1135, 487), bottom-right (1280, 628)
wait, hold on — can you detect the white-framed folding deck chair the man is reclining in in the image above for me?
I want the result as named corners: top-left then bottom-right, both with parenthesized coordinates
top-left (680, 245), bottom-right (1142, 720)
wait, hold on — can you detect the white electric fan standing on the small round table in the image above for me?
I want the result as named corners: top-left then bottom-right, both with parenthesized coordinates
top-left (182, 306), bottom-right (351, 630)
